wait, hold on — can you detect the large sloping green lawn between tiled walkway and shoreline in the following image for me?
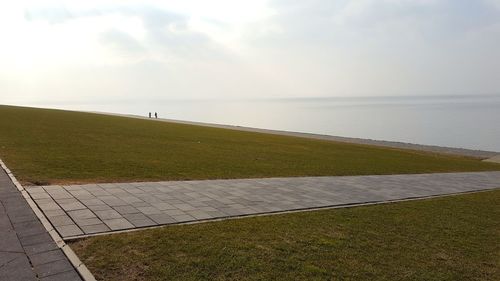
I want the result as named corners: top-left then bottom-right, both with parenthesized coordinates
top-left (0, 106), bottom-right (500, 184)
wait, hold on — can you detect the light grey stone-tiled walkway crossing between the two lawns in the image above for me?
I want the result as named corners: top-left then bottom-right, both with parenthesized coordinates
top-left (26, 172), bottom-right (500, 239)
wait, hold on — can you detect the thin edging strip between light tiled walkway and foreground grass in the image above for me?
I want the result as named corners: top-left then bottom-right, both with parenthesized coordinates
top-left (64, 187), bottom-right (500, 241)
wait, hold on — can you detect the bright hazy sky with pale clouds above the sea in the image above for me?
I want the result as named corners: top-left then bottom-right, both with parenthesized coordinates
top-left (0, 0), bottom-right (500, 104)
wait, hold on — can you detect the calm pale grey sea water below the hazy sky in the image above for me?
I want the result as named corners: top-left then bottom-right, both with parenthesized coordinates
top-left (35, 95), bottom-right (500, 151)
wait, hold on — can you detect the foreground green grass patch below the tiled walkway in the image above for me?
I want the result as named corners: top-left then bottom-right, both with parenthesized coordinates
top-left (71, 190), bottom-right (500, 281)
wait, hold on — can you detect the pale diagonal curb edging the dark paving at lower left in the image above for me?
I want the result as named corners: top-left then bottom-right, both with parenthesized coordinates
top-left (0, 159), bottom-right (96, 281)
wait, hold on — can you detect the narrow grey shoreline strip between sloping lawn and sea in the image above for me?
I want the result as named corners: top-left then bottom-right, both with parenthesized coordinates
top-left (89, 111), bottom-right (500, 159)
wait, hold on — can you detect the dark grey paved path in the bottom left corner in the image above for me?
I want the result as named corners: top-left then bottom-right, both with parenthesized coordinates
top-left (0, 168), bottom-right (81, 281)
